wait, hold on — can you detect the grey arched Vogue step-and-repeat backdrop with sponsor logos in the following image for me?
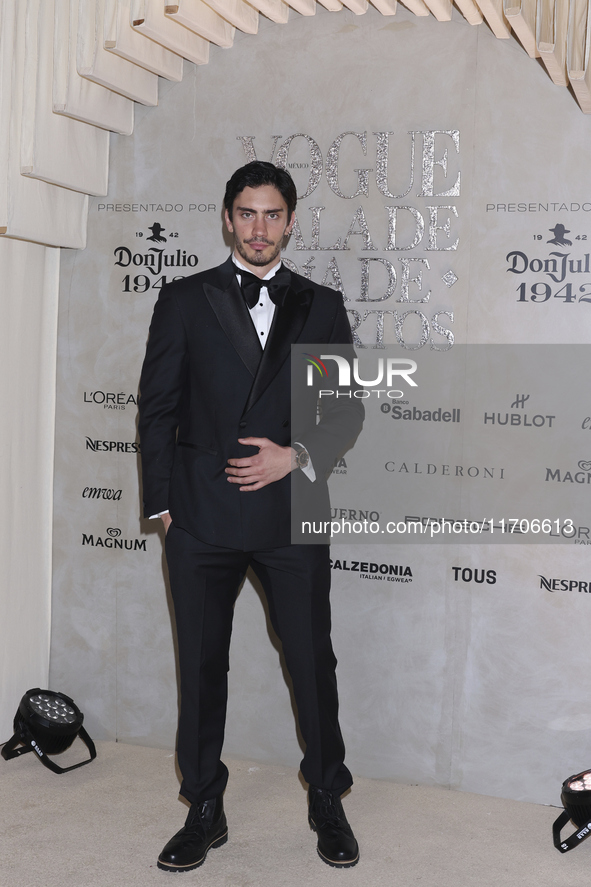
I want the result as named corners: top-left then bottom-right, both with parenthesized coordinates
top-left (51, 8), bottom-right (591, 803)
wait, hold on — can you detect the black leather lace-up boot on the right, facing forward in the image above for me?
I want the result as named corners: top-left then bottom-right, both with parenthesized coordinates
top-left (308, 785), bottom-right (359, 869)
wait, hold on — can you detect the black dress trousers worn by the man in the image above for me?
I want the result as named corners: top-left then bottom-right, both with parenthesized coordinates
top-left (166, 524), bottom-right (353, 803)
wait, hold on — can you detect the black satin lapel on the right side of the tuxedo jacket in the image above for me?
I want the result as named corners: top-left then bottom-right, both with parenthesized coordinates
top-left (244, 287), bottom-right (313, 413)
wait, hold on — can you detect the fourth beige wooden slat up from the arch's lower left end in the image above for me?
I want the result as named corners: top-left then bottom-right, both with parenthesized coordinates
top-left (76, 0), bottom-right (158, 105)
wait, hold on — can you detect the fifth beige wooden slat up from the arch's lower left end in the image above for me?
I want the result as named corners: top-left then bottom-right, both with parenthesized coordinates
top-left (103, 0), bottom-right (183, 83)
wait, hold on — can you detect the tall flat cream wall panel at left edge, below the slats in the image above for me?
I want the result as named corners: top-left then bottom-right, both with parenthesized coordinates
top-left (0, 238), bottom-right (60, 739)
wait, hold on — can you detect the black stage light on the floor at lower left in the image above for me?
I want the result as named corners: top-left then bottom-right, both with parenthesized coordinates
top-left (2, 687), bottom-right (96, 773)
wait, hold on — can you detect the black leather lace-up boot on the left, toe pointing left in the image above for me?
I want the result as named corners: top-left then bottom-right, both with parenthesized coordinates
top-left (158, 795), bottom-right (228, 872)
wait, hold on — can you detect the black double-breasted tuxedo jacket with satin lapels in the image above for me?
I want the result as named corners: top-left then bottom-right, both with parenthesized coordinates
top-left (139, 253), bottom-right (363, 551)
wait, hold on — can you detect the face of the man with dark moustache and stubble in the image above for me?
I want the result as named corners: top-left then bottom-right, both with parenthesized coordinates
top-left (225, 185), bottom-right (294, 277)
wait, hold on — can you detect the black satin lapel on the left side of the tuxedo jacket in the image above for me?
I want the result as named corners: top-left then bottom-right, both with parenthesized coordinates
top-left (203, 267), bottom-right (263, 376)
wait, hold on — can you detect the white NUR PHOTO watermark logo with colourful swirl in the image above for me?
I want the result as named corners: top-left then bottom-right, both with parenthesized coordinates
top-left (302, 352), bottom-right (417, 400)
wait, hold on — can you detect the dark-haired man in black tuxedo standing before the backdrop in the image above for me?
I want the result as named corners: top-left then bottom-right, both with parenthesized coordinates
top-left (139, 161), bottom-right (363, 871)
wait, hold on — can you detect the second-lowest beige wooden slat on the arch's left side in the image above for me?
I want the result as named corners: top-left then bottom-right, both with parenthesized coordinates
top-left (21, 0), bottom-right (109, 195)
